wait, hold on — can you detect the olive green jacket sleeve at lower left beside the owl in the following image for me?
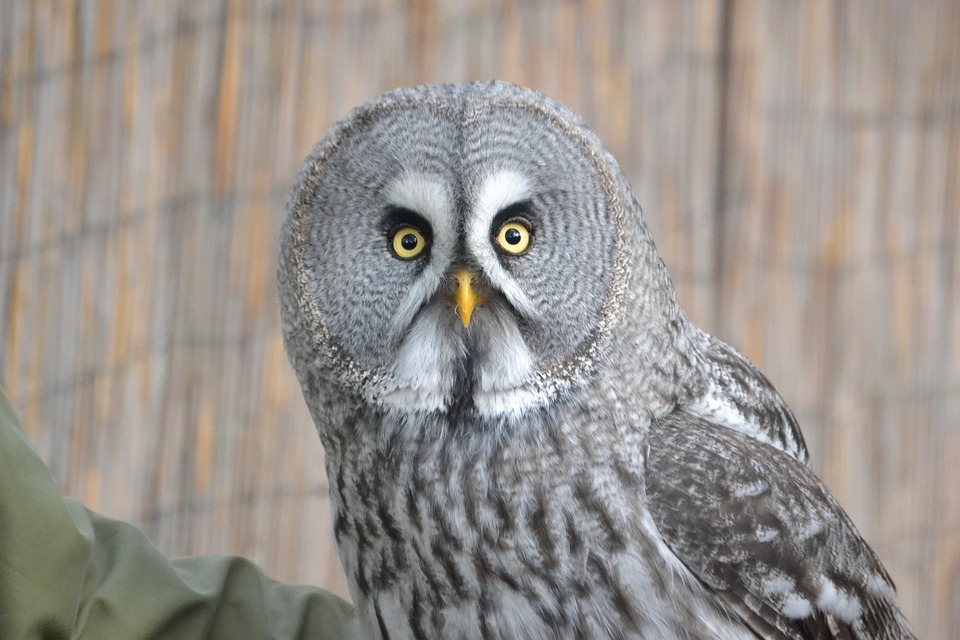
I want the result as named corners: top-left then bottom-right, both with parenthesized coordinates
top-left (0, 390), bottom-right (358, 640)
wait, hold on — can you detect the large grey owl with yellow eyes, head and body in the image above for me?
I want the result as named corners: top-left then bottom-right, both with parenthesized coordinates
top-left (278, 82), bottom-right (912, 640)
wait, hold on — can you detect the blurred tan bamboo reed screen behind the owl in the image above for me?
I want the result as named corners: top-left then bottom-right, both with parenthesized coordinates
top-left (0, 0), bottom-right (960, 638)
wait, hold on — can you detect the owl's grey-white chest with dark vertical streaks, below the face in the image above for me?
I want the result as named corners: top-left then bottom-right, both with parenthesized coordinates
top-left (328, 422), bottom-right (752, 638)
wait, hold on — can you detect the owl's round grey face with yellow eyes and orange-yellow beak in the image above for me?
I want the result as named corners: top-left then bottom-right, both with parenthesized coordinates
top-left (281, 85), bottom-right (622, 416)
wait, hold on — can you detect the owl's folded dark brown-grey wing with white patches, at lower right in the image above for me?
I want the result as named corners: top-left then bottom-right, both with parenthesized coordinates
top-left (646, 410), bottom-right (913, 640)
